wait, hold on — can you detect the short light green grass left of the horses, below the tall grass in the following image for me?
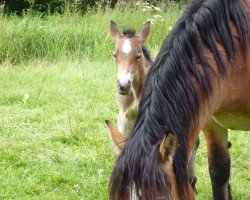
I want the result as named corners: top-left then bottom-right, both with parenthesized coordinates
top-left (0, 60), bottom-right (117, 199)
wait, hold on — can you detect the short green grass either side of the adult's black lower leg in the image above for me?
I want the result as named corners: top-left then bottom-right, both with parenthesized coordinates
top-left (196, 131), bottom-right (250, 200)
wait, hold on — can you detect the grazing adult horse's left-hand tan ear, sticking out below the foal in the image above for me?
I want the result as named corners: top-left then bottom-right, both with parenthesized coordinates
top-left (105, 120), bottom-right (128, 155)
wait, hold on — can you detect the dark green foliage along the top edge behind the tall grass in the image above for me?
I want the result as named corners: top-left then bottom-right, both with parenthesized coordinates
top-left (0, 0), bottom-right (186, 15)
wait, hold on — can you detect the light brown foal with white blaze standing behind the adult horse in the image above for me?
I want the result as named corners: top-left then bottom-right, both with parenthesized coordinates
top-left (110, 21), bottom-right (152, 136)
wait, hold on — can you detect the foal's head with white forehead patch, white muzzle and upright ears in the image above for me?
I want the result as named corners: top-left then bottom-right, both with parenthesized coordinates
top-left (110, 21), bottom-right (151, 95)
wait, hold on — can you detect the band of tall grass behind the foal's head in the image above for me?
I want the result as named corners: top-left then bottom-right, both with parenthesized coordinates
top-left (0, 5), bottom-right (182, 63)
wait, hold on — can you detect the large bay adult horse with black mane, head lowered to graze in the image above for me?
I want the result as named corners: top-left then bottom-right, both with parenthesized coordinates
top-left (109, 0), bottom-right (250, 200)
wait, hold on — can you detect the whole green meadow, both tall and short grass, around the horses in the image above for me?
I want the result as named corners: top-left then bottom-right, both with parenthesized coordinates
top-left (0, 5), bottom-right (250, 200)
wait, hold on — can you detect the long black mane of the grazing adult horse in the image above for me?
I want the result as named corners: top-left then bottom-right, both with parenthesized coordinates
top-left (110, 0), bottom-right (248, 200)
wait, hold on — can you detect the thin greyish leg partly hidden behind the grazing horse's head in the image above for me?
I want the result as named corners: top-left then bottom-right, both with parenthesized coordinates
top-left (188, 138), bottom-right (200, 193)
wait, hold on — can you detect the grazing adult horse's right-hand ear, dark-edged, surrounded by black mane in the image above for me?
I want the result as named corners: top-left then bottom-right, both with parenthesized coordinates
top-left (159, 131), bottom-right (178, 162)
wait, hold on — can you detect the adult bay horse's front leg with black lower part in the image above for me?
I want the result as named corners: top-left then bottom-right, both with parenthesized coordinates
top-left (202, 119), bottom-right (232, 200)
